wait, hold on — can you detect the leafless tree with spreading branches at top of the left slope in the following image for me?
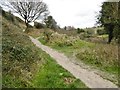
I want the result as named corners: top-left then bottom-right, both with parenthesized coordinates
top-left (3, 0), bottom-right (48, 30)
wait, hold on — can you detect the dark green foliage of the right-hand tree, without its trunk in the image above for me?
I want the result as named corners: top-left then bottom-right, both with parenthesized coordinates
top-left (98, 2), bottom-right (118, 25)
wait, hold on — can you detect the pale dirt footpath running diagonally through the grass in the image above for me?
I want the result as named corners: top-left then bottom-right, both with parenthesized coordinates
top-left (30, 37), bottom-right (117, 88)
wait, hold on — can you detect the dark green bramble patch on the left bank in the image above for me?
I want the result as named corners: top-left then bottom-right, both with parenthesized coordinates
top-left (2, 38), bottom-right (35, 61)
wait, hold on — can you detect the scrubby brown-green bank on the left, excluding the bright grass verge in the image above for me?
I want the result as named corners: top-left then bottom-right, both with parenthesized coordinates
top-left (2, 11), bottom-right (42, 87)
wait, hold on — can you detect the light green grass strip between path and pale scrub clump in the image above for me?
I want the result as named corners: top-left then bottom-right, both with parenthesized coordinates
top-left (39, 38), bottom-right (95, 56)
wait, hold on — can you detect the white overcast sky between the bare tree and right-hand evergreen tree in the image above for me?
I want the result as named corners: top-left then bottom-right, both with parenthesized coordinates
top-left (43, 0), bottom-right (105, 28)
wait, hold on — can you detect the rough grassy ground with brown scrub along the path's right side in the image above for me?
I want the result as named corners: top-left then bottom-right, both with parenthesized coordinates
top-left (39, 31), bottom-right (118, 84)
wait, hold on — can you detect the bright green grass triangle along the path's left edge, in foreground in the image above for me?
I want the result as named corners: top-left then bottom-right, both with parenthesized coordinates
top-left (33, 52), bottom-right (87, 88)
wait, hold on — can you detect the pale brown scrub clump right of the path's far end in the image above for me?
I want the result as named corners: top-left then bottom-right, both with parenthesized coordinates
top-left (39, 31), bottom-right (74, 47)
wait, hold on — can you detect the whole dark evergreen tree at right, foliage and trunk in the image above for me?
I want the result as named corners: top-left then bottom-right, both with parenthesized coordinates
top-left (98, 2), bottom-right (120, 43)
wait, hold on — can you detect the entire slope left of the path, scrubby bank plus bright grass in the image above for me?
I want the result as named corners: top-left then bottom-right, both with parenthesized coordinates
top-left (2, 10), bottom-right (86, 88)
